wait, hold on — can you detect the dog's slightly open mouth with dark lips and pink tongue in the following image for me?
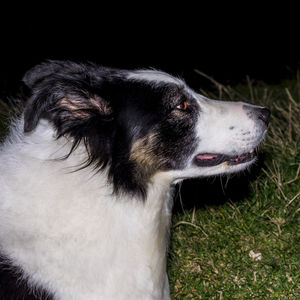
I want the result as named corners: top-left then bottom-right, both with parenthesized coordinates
top-left (195, 150), bottom-right (256, 167)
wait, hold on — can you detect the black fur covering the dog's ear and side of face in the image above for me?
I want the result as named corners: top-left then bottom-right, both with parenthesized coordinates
top-left (24, 61), bottom-right (199, 196)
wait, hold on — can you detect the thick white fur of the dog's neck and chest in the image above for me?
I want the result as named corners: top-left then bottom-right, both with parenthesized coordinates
top-left (0, 119), bottom-right (172, 300)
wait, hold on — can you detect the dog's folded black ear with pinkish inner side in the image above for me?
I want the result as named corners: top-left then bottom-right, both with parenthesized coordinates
top-left (23, 61), bottom-right (113, 135)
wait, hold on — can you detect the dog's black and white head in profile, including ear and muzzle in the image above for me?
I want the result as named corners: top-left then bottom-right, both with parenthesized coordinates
top-left (23, 61), bottom-right (269, 194)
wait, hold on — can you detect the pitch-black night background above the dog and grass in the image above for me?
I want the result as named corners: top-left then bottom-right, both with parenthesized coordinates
top-left (0, 10), bottom-right (300, 98)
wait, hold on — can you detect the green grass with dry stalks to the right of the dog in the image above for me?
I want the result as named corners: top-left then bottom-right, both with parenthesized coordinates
top-left (168, 74), bottom-right (300, 299)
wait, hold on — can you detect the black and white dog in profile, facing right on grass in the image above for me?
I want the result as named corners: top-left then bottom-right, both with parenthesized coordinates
top-left (0, 61), bottom-right (270, 300)
